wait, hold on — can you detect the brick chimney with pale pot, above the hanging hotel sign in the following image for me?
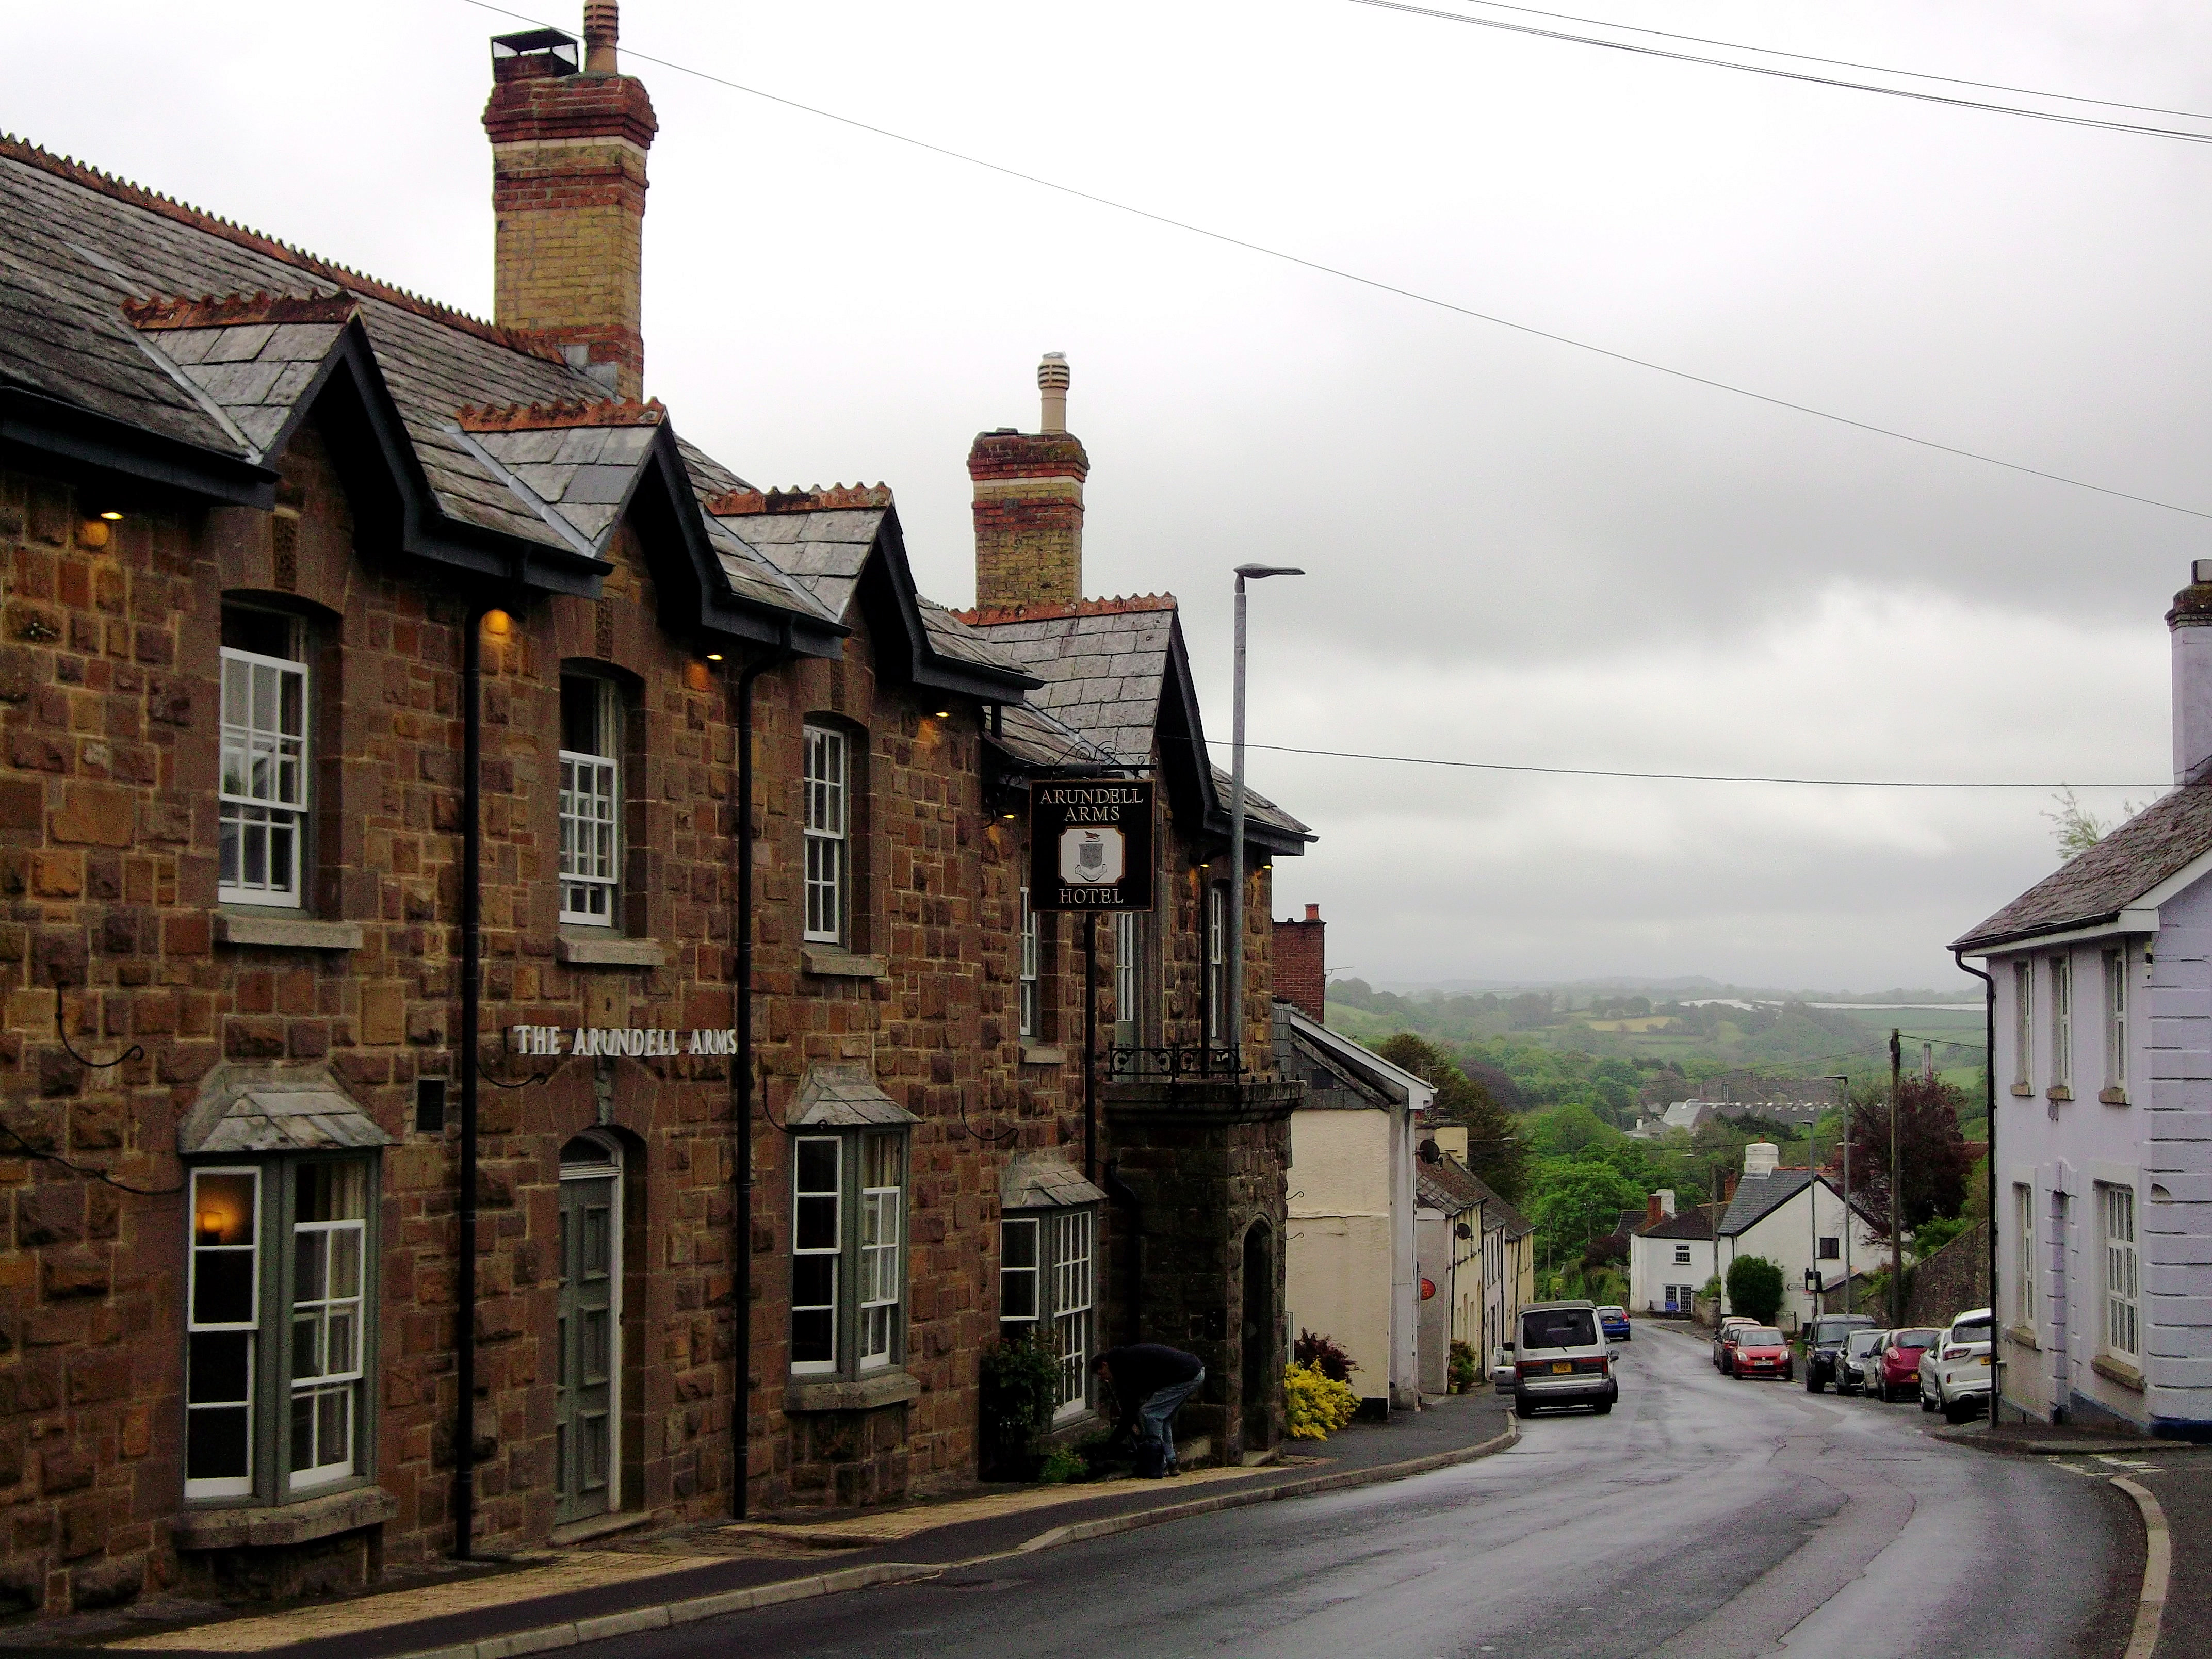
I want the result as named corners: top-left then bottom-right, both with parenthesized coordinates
top-left (969, 352), bottom-right (1093, 610)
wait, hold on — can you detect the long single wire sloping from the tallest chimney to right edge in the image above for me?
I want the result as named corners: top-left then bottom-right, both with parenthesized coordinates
top-left (462, 0), bottom-right (2212, 520)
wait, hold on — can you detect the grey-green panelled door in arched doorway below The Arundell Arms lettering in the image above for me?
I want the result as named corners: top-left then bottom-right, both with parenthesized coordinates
top-left (553, 1130), bottom-right (622, 1524)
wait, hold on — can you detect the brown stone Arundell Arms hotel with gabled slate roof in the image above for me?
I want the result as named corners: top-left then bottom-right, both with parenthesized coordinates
top-left (0, 0), bottom-right (1309, 1613)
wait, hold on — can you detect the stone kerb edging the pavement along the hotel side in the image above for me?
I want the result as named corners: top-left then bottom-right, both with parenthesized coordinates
top-left (367, 1422), bottom-right (1522, 1659)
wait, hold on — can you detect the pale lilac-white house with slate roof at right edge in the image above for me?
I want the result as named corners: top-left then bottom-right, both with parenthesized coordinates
top-left (1951, 560), bottom-right (2212, 1440)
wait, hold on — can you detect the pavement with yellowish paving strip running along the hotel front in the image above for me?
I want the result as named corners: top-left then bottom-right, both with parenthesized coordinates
top-left (0, 1389), bottom-right (1513, 1659)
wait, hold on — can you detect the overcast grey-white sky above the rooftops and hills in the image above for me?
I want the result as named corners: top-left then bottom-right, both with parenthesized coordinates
top-left (21, 0), bottom-right (2212, 989)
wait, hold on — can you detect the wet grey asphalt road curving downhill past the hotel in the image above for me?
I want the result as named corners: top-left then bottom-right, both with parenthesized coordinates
top-left (595, 1325), bottom-right (2135, 1659)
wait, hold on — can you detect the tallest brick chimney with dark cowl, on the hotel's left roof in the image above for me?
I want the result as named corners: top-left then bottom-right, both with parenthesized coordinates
top-left (484, 0), bottom-right (659, 398)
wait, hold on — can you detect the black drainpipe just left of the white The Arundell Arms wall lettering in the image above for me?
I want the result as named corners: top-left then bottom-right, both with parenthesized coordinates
top-left (453, 601), bottom-right (486, 1562)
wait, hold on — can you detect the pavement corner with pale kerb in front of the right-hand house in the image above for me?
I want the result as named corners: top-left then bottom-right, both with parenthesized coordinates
top-left (1938, 1422), bottom-right (2212, 1659)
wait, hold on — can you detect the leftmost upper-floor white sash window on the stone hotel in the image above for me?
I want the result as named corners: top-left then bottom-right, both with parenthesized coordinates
top-left (215, 604), bottom-right (307, 909)
